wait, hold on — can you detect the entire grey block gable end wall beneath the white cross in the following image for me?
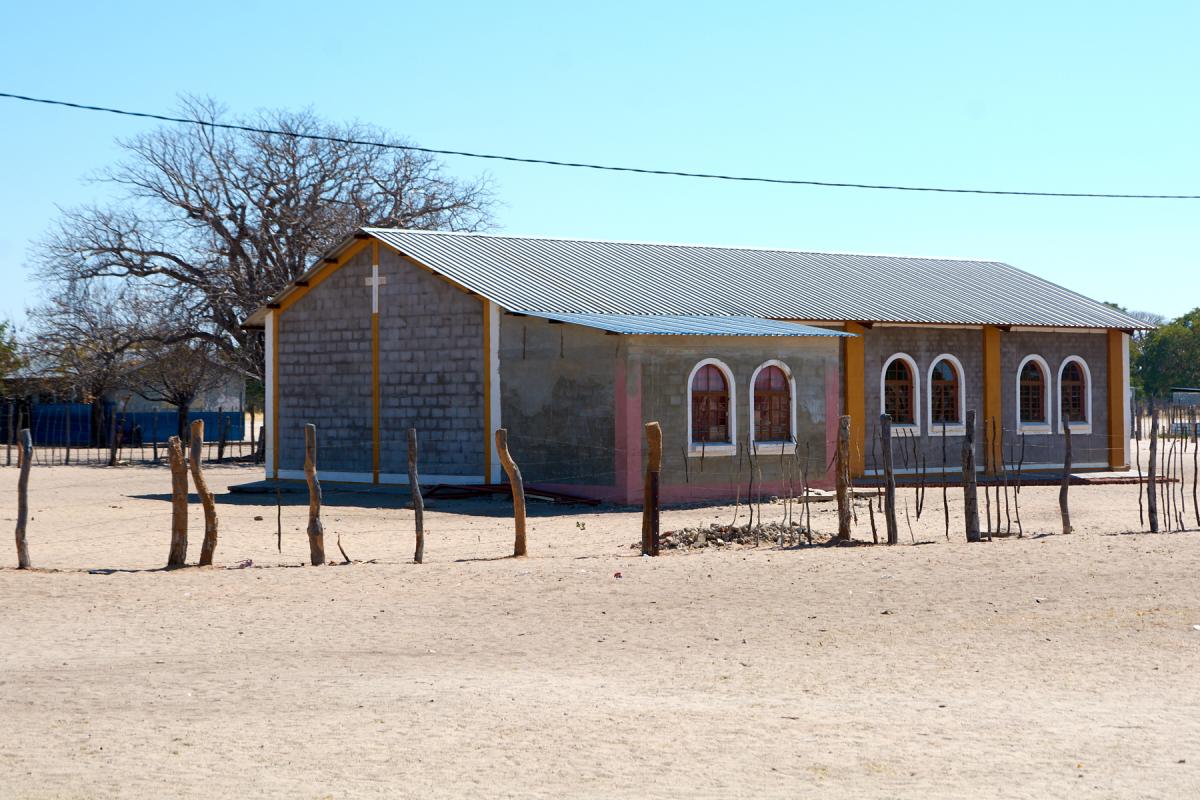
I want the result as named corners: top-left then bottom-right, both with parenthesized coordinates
top-left (278, 247), bottom-right (486, 477)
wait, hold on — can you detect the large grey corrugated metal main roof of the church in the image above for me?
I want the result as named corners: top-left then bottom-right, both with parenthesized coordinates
top-left (364, 228), bottom-right (1142, 329)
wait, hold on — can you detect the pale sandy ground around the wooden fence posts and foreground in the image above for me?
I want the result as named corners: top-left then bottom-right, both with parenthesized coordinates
top-left (0, 441), bottom-right (1200, 798)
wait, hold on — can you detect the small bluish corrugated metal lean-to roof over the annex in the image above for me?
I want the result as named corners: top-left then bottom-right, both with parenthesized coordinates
top-left (522, 311), bottom-right (850, 337)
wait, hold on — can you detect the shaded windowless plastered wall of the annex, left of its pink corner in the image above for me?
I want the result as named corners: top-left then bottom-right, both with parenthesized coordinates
top-left (500, 313), bottom-right (624, 486)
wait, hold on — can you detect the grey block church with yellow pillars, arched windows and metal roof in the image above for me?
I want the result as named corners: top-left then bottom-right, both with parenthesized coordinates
top-left (246, 228), bottom-right (1142, 501)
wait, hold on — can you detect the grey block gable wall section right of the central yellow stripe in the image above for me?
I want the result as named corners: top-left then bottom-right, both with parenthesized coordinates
top-left (379, 247), bottom-right (487, 477)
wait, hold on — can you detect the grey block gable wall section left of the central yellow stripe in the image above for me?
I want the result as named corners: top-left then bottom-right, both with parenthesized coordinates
top-left (278, 248), bottom-right (372, 473)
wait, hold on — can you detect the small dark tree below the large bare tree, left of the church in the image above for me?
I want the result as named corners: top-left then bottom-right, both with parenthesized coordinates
top-left (128, 341), bottom-right (228, 441)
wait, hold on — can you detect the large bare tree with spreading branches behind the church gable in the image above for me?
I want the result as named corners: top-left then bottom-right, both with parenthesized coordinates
top-left (36, 98), bottom-right (492, 378)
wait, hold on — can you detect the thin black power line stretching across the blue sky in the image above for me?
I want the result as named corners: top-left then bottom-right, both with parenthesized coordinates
top-left (0, 91), bottom-right (1200, 200)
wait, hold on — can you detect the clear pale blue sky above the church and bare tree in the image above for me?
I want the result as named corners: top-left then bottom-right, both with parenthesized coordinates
top-left (0, 0), bottom-right (1200, 328)
